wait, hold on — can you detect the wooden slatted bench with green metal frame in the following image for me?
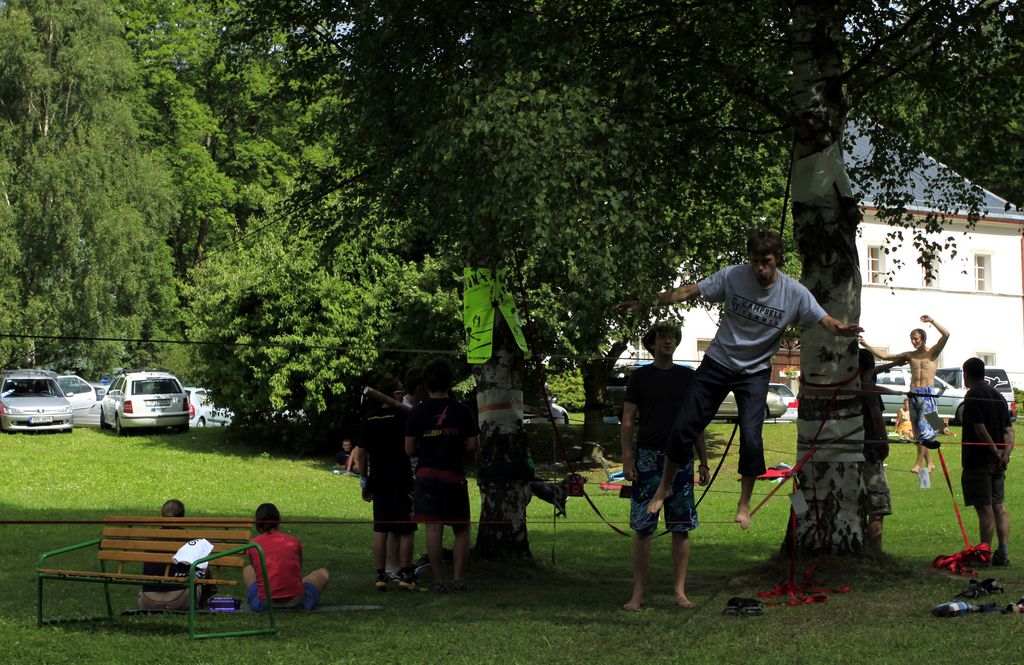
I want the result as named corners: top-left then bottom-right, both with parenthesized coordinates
top-left (36, 516), bottom-right (278, 639)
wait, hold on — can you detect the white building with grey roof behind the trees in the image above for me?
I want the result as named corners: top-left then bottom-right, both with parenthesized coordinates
top-left (626, 127), bottom-right (1024, 387)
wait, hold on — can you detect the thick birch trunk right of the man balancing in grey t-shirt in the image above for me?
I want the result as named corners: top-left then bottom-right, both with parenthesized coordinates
top-left (791, 0), bottom-right (865, 553)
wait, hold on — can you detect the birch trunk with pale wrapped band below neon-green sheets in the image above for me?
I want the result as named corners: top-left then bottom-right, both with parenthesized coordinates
top-left (476, 311), bottom-right (534, 558)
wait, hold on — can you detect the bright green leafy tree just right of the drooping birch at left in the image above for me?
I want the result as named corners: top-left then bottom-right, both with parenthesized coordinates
top-left (115, 0), bottom-right (303, 279)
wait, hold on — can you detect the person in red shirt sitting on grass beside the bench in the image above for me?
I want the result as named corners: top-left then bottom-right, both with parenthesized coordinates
top-left (242, 503), bottom-right (330, 612)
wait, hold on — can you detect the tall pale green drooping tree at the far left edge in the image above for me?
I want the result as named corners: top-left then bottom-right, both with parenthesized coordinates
top-left (0, 0), bottom-right (177, 374)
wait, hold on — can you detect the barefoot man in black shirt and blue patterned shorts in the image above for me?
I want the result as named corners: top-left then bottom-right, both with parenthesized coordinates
top-left (622, 322), bottom-right (709, 610)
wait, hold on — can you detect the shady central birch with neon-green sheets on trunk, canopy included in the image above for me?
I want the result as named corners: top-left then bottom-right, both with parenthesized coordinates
top-left (243, 2), bottom-right (781, 555)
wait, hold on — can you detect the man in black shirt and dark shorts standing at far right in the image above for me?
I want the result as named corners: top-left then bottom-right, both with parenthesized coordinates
top-left (961, 358), bottom-right (1014, 566)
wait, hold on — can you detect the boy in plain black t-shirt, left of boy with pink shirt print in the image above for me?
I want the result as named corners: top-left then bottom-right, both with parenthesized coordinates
top-left (359, 378), bottom-right (416, 591)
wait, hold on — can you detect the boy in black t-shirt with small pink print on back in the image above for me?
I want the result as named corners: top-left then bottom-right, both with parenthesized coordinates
top-left (406, 358), bottom-right (480, 592)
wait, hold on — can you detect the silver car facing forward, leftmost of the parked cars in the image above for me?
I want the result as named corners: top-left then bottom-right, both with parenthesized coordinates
top-left (0, 370), bottom-right (73, 431)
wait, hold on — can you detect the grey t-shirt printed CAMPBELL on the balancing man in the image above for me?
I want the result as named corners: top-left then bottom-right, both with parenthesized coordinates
top-left (697, 263), bottom-right (825, 374)
